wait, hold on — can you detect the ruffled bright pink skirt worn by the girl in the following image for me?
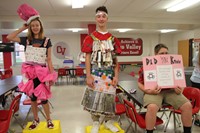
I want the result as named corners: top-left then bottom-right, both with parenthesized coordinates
top-left (18, 63), bottom-right (58, 100)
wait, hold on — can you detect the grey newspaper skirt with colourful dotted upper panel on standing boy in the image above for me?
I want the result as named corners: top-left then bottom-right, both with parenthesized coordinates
top-left (81, 70), bottom-right (116, 117)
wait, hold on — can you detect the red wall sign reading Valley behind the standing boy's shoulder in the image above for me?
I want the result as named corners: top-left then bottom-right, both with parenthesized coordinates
top-left (118, 38), bottom-right (143, 56)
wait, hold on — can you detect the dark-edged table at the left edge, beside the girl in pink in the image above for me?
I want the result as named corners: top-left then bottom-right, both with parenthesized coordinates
top-left (0, 75), bottom-right (22, 106)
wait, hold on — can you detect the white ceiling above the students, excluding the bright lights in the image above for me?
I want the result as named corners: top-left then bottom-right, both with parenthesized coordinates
top-left (0, 0), bottom-right (200, 34)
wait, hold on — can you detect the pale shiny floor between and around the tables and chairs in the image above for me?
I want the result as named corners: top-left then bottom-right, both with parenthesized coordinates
top-left (8, 85), bottom-right (200, 133)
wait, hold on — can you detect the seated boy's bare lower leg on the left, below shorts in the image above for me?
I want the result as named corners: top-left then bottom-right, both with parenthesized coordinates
top-left (145, 104), bottom-right (159, 130)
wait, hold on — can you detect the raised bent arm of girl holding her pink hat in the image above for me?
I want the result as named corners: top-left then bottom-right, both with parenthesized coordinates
top-left (7, 24), bottom-right (28, 43)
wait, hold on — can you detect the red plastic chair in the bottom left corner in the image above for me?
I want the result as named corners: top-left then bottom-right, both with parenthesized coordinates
top-left (0, 94), bottom-right (22, 133)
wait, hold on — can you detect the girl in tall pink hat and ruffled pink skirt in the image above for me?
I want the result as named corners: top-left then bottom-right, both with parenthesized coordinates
top-left (7, 4), bottom-right (57, 130)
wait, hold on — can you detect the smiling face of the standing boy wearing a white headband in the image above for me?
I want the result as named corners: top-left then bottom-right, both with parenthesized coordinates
top-left (96, 12), bottom-right (108, 27)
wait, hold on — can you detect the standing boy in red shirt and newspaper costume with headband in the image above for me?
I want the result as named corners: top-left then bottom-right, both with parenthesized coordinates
top-left (82, 6), bottom-right (121, 133)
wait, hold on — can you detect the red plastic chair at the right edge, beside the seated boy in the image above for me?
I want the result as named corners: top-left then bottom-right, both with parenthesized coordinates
top-left (164, 87), bottom-right (200, 131)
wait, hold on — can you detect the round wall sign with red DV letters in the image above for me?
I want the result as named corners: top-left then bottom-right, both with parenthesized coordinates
top-left (53, 42), bottom-right (70, 59)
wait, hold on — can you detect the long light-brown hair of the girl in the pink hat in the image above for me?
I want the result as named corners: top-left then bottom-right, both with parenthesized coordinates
top-left (27, 18), bottom-right (44, 41)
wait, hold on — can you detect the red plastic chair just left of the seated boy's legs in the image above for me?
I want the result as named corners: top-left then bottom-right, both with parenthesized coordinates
top-left (124, 99), bottom-right (163, 133)
